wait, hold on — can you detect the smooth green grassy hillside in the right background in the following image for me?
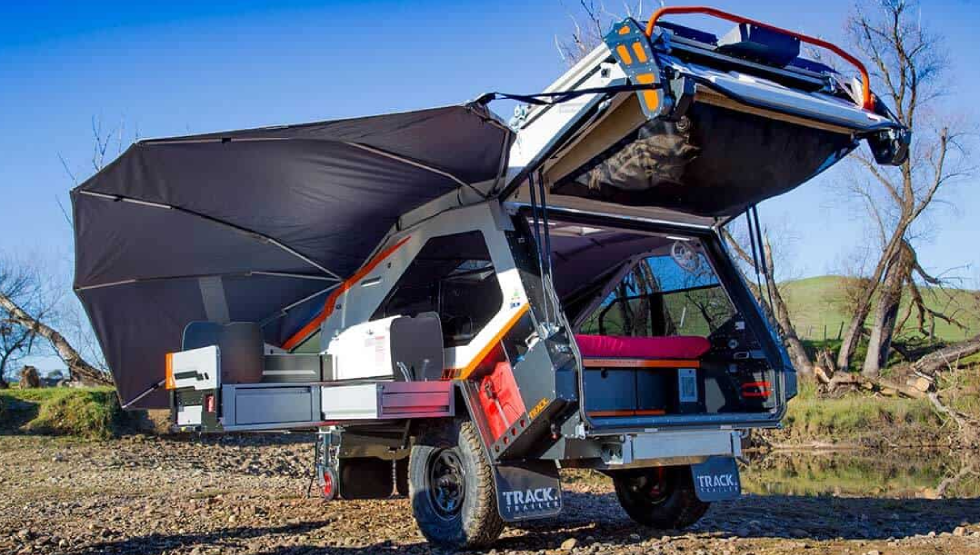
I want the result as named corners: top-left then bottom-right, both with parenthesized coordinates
top-left (780, 276), bottom-right (980, 341)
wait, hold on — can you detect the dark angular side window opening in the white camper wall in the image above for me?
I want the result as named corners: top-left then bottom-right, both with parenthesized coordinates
top-left (372, 231), bottom-right (503, 347)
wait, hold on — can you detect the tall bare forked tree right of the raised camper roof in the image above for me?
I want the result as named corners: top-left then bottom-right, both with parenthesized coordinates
top-left (837, 0), bottom-right (971, 377)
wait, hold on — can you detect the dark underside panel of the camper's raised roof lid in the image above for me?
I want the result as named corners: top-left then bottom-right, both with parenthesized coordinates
top-left (548, 96), bottom-right (857, 219)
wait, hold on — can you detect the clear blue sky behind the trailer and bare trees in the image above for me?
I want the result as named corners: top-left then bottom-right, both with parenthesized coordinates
top-left (0, 0), bottom-right (980, 286)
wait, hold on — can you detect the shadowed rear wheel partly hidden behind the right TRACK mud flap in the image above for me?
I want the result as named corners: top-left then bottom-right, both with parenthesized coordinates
top-left (613, 466), bottom-right (710, 530)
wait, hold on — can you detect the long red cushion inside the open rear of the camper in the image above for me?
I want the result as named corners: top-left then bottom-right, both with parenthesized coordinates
top-left (575, 335), bottom-right (711, 360)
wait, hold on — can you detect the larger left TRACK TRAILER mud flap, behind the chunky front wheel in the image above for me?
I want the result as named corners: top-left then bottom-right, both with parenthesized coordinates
top-left (493, 461), bottom-right (561, 522)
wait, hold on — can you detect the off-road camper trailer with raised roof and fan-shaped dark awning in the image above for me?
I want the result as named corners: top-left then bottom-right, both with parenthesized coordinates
top-left (72, 8), bottom-right (908, 547)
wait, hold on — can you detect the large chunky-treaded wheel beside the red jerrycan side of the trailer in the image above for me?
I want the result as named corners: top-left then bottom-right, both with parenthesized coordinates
top-left (408, 422), bottom-right (504, 549)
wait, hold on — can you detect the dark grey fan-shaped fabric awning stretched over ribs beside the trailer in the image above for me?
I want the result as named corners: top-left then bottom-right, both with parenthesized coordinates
top-left (72, 105), bottom-right (512, 408)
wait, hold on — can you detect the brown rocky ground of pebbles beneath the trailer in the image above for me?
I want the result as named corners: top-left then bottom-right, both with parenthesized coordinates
top-left (0, 435), bottom-right (980, 555)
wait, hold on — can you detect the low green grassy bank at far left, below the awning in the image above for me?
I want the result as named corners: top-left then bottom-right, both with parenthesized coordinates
top-left (0, 387), bottom-right (127, 439)
